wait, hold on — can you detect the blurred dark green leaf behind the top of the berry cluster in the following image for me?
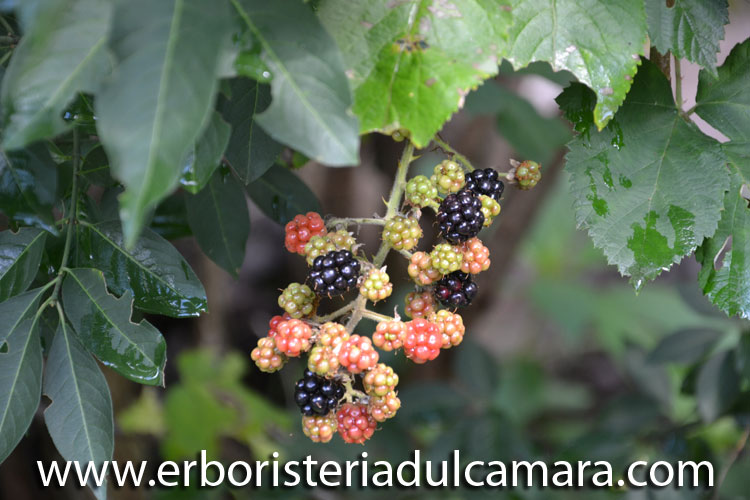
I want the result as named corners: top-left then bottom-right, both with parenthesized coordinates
top-left (466, 82), bottom-right (571, 164)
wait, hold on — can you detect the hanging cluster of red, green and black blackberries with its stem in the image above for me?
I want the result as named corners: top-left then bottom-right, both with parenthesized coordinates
top-left (251, 143), bottom-right (541, 444)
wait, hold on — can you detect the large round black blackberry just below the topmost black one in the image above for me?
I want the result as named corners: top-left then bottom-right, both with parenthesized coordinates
top-left (437, 189), bottom-right (484, 245)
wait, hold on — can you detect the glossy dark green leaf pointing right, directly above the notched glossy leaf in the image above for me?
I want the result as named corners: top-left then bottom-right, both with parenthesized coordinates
top-left (77, 221), bottom-right (206, 318)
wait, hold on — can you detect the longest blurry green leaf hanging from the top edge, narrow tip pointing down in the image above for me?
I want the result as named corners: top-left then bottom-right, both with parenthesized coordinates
top-left (96, 0), bottom-right (232, 247)
